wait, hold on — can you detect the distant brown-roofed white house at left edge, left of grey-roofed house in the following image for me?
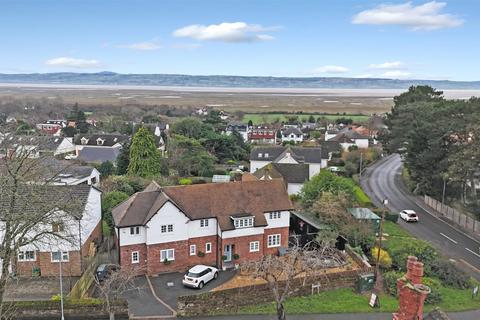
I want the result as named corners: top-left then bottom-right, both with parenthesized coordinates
top-left (0, 135), bottom-right (75, 158)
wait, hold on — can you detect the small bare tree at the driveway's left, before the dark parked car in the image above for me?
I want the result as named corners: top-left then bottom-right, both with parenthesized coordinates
top-left (94, 266), bottom-right (140, 320)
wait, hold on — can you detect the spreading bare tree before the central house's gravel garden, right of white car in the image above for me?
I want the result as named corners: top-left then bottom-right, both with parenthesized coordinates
top-left (242, 238), bottom-right (346, 320)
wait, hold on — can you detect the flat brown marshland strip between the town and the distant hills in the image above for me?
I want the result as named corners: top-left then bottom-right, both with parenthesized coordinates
top-left (0, 84), bottom-right (399, 115)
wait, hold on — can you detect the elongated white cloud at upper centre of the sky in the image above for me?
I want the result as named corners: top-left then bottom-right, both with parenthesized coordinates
top-left (173, 22), bottom-right (278, 42)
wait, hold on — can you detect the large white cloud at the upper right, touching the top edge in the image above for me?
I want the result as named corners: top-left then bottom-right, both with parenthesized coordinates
top-left (352, 1), bottom-right (463, 30)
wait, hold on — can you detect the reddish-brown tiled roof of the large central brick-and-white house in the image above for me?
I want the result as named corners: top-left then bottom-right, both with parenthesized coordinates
top-left (112, 180), bottom-right (293, 231)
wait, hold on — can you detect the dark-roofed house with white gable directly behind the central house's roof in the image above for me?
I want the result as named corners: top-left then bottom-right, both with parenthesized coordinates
top-left (253, 163), bottom-right (310, 195)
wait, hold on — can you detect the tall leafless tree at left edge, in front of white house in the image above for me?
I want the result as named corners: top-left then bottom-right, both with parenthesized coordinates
top-left (0, 146), bottom-right (82, 318)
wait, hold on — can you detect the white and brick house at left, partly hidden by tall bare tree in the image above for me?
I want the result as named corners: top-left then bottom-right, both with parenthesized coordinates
top-left (0, 184), bottom-right (102, 277)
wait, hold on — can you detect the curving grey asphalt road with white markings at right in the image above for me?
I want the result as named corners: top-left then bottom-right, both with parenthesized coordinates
top-left (361, 155), bottom-right (480, 280)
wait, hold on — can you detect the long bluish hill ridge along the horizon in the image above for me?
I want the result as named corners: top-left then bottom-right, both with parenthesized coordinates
top-left (0, 71), bottom-right (480, 89)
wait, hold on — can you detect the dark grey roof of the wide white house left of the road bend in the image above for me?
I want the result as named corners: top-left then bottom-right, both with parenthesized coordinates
top-left (250, 146), bottom-right (328, 163)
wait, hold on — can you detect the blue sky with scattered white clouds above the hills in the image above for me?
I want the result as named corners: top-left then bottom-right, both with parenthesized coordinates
top-left (0, 0), bottom-right (480, 81)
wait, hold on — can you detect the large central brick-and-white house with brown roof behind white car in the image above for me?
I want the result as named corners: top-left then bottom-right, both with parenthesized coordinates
top-left (112, 180), bottom-right (293, 275)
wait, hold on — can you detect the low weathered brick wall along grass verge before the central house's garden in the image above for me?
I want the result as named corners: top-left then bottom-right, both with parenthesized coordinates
top-left (177, 270), bottom-right (371, 317)
